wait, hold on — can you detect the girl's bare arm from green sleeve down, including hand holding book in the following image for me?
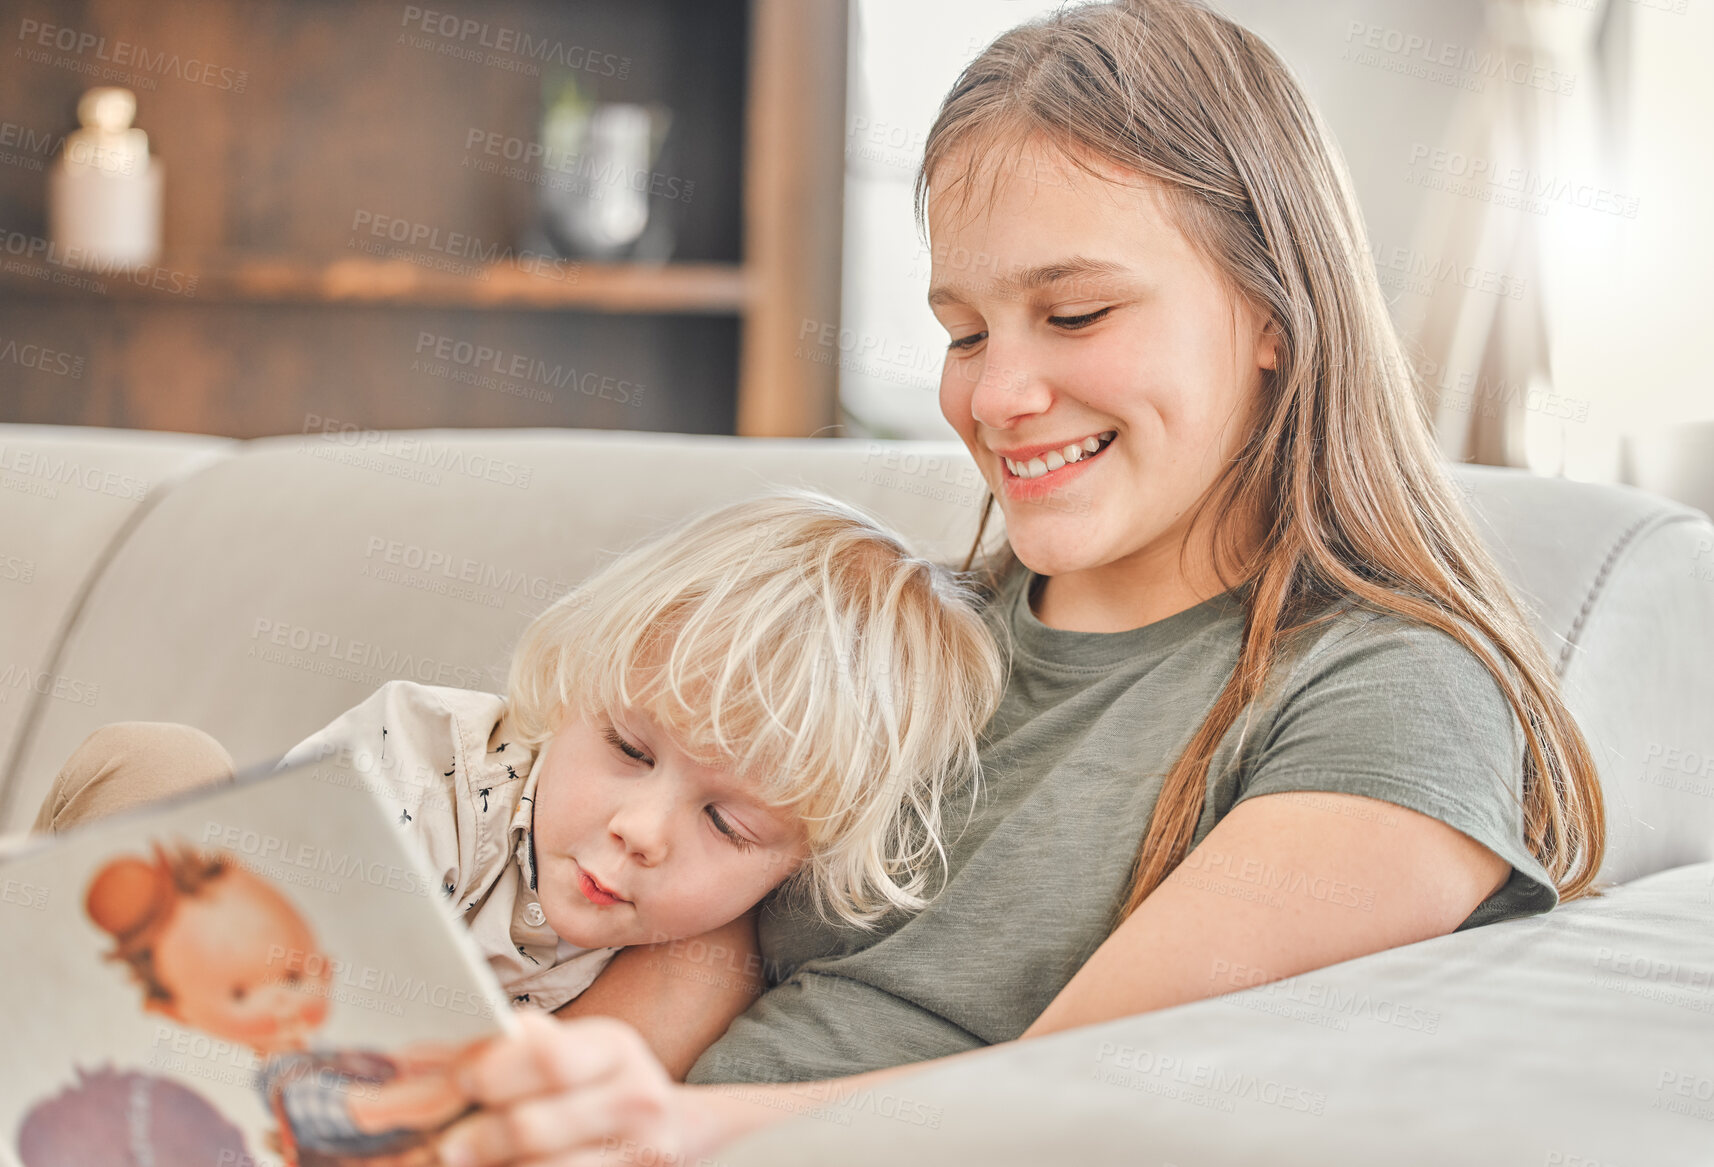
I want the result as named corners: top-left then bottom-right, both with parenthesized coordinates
top-left (444, 793), bottom-right (1510, 1167)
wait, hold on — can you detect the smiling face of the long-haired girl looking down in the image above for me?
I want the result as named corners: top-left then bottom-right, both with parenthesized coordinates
top-left (927, 141), bottom-right (1275, 631)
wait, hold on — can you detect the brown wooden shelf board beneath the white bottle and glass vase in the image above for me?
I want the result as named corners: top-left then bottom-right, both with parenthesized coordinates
top-left (0, 255), bottom-right (749, 315)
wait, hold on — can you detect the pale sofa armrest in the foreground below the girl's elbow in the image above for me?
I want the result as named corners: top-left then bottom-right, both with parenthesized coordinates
top-left (720, 864), bottom-right (1714, 1167)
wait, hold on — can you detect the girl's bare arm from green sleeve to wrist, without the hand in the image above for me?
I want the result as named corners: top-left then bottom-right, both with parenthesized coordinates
top-left (687, 793), bottom-right (1512, 1146)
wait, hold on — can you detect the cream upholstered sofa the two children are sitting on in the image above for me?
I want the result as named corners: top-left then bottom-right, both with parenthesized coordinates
top-left (0, 425), bottom-right (1714, 1167)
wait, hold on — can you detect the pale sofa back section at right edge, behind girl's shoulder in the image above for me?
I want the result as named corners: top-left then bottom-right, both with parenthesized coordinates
top-left (1457, 466), bottom-right (1714, 883)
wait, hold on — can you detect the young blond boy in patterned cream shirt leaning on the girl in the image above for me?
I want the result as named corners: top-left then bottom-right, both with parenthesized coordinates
top-left (38, 490), bottom-right (1004, 1011)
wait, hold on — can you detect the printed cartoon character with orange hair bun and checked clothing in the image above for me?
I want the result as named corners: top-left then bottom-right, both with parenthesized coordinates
top-left (84, 843), bottom-right (464, 1167)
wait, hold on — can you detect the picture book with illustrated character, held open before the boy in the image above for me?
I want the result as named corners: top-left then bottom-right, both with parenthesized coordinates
top-left (0, 759), bottom-right (516, 1167)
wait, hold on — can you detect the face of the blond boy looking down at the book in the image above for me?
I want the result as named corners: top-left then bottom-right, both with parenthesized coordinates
top-left (535, 709), bottom-right (809, 948)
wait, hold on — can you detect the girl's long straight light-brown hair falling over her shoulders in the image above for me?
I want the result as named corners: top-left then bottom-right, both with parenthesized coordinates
top-left (915, 0), bottom-right (1606, 920)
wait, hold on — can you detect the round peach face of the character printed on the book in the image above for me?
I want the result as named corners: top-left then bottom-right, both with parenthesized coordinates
top-left (154, 869), bottom-right (331, 1054)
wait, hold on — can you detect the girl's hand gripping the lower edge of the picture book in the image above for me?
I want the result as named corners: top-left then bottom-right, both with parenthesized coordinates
top-left (440, 1013), bottom-right (716, 1167)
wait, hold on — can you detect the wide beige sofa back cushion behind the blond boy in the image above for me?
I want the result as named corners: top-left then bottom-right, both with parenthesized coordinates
top-left (5, 430), bottom-right (984, 829)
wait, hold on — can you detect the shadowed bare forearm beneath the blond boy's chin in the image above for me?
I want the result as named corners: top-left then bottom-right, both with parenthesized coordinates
top-left (554, 908), bottom-right (768, 1081)
